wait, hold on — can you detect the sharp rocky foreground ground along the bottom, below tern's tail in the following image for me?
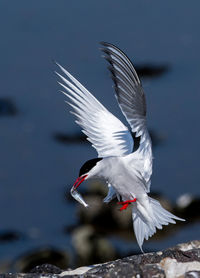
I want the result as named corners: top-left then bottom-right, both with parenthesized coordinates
top-left (0, 240), bottom-right (200, 278)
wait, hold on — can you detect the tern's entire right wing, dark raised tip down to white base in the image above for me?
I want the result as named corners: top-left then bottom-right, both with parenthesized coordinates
top-left (101, 42), bottom-right (152, 191)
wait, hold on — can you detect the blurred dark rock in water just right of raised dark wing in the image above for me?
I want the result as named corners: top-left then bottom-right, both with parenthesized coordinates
top-left (135, 64), bottom-right (169, 78)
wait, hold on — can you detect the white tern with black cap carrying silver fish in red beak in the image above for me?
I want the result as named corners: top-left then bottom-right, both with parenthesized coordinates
top-left (55, 42), bottom-right (185, 252)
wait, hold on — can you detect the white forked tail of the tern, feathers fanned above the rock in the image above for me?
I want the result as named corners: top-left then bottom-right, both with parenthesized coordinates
top-left (132, 197), bottom-right (185, 252)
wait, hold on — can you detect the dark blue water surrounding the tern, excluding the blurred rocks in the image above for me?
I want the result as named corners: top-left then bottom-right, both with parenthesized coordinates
top-left (0, 0), bottom-right (200, 272)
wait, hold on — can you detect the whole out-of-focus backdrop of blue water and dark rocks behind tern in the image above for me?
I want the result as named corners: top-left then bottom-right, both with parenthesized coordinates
top-left (0, 0), bottom-right (200, 272)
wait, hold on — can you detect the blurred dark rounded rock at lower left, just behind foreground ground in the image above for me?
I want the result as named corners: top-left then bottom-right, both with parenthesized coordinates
top-left (13, 247), bottom-right (69, 272)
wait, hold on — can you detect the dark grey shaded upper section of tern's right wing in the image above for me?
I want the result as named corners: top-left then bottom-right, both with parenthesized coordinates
top-left (101, 42), bottom-right (146, 136)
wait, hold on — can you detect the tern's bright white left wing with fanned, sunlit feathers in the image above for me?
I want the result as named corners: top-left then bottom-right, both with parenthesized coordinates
top-left (56, 63), bottom-right (133, 157)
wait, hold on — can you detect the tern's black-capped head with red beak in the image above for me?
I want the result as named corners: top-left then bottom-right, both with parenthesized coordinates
top-left (73, 158), bottom-right (102, 189)
